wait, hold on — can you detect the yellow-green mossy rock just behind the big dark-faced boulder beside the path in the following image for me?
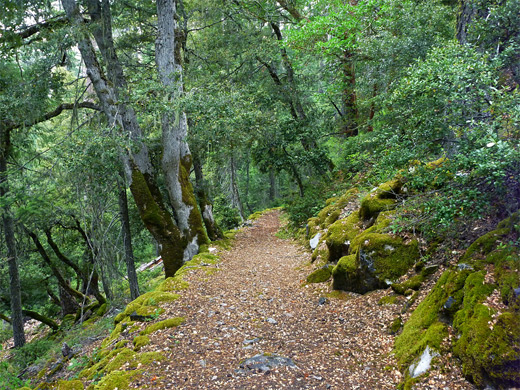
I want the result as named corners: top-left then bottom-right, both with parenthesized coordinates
top-left (324, 212), bottom-right (361, 262)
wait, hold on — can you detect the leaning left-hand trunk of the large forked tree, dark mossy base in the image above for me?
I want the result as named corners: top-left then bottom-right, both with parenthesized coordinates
top-left (62, 0), bottom-right (194, 277)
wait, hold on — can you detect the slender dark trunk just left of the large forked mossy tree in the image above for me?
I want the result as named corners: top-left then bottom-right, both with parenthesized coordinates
top-left (119, 178), bottom-right (140, 300)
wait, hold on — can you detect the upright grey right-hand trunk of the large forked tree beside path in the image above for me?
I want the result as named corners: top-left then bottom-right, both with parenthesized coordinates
top-left (155, 0), bottom-right (208, 261)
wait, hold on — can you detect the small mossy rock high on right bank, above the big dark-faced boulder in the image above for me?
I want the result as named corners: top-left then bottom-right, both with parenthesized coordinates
top-left (359, 179), bottom-right (403, 221)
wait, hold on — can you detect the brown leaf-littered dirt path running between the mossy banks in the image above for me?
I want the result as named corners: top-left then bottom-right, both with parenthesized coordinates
top-left (130, 211), bottom-right (474, 390)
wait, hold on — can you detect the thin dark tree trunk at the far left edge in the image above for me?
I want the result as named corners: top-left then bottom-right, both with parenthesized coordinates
top-left (0, 122), bottom-right (25, 348)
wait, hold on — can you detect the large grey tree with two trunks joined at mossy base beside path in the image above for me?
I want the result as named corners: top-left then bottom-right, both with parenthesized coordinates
top-left (62, 0), bottom-right (207, 277)
